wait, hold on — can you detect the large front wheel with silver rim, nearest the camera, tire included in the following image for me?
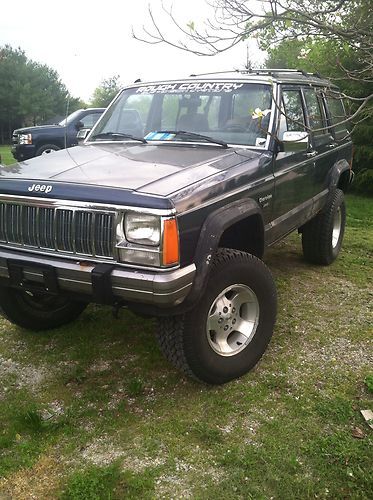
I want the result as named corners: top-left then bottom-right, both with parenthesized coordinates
top-left (157, 248), bottom-right (277, 384)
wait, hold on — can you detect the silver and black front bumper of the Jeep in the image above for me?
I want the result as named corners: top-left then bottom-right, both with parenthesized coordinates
top-left (0, 248), bottom-right (196, 308)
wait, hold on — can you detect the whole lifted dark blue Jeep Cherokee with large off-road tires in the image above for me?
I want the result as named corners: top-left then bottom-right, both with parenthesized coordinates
top-left (0, 70), bottom-right (353, 384)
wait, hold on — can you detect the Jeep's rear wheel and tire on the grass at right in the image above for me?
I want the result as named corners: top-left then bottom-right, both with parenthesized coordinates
top-left (302, 189), bottom-right (346, 266)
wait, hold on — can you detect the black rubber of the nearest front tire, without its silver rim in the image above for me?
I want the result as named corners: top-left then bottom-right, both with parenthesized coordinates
top-left (156, 248), bottom-right (277, 384)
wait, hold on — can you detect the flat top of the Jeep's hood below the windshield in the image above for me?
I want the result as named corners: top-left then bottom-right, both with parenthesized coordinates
top-left (0, 143), bottom-right (260, 196)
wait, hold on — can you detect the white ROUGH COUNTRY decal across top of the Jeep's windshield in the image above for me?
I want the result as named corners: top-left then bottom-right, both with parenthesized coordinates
top-left (136, 82), bottom-right (244, 94)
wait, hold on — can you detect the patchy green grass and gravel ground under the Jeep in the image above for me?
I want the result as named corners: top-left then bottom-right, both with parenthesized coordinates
top-left (0, 154), bottom-right (373, 500)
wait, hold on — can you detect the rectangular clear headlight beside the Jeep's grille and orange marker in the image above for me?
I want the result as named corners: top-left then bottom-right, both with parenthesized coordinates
top-left (124, 213), bottom-right (161, 246)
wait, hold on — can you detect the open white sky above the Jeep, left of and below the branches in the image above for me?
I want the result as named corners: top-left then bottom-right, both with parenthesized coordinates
top-left (0, 0), bottom-right (263, 101)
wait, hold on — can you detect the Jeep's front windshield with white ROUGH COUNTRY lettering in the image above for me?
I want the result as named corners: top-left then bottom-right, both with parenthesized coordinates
top-left (89, 81), bottom-right (272, 148)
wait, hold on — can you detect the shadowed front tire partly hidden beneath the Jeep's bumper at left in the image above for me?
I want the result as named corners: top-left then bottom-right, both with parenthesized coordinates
top-left (0, 287), bottom-right (87, 331)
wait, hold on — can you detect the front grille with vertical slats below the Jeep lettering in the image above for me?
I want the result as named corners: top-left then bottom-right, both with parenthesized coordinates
top-left (0, 201), bottom-right (115, 258)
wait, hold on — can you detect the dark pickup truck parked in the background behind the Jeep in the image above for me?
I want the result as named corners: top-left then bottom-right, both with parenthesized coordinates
top-left (12, 108), bottom-right (105, 161)
